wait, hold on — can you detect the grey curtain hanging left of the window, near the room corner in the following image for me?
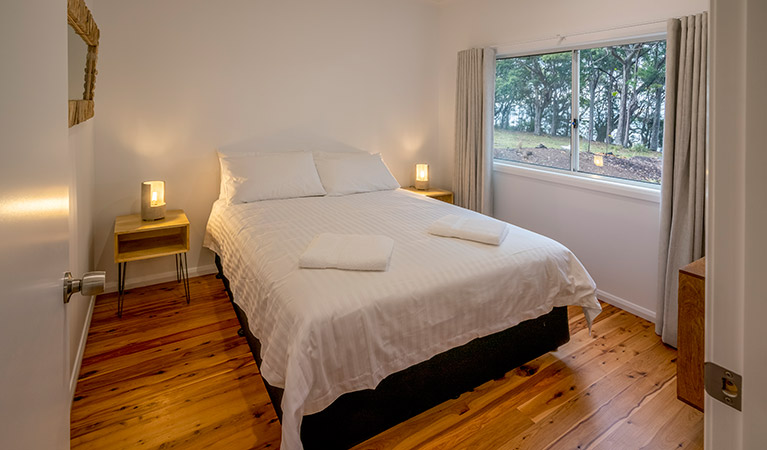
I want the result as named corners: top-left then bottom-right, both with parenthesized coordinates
top-left (453, 48), bottom-right (495, 215)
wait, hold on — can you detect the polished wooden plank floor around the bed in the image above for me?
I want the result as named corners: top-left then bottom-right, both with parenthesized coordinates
top-left (71, 275), bottom-right (703, 450)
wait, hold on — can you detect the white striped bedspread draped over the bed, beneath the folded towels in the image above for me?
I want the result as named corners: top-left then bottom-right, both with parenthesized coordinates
top-left (204, 190), bottom-right (601, 450)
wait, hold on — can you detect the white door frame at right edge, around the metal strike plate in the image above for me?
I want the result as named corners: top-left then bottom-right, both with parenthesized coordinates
top-left (705, 0), bottom-right (767, 450)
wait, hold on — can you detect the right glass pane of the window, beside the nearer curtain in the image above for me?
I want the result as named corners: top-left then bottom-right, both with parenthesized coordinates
top-left (578, 41), bottom-right (666, 183)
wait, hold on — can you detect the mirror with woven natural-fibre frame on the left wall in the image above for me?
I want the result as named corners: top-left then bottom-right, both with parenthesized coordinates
top-left (67, 0), bottom-right (100, 127)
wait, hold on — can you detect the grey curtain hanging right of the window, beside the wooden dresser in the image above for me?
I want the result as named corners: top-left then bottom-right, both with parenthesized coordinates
top-left (655, 13), bottom-right (708, 347)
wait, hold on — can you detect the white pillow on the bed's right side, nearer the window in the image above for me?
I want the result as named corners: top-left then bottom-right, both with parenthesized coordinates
top-left (314, 152), bottom-right (400, 196)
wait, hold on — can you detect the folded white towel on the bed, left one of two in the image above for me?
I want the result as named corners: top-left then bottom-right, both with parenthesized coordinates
top-left (298, 233), bottom-right (394, 272)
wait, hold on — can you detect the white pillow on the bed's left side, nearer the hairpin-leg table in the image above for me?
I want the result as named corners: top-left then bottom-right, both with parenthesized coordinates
top-left (219, 152), bottom-right (325, 203)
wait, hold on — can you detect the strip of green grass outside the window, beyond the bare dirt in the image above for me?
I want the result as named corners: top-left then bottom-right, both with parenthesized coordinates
top-left (493, 128), bottom-right (663, 159)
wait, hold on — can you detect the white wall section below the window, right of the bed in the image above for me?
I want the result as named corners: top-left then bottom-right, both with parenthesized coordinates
top-left (493, 171), bottom-right (659, 320)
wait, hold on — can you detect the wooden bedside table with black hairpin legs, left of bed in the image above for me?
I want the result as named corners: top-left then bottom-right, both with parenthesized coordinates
top-left (115, 209), bottom-right (190, 317)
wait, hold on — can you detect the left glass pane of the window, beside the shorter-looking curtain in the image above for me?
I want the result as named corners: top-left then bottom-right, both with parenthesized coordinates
top-left (493, 52), bottom-right (572, 170)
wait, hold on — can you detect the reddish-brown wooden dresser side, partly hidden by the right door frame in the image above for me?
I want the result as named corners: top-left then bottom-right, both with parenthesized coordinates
top-left (676, 257), bottom-right (706, 411)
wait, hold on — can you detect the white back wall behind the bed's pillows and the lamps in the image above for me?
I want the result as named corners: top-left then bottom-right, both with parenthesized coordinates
top-left (94, 0), bottom-right (444, 288)
